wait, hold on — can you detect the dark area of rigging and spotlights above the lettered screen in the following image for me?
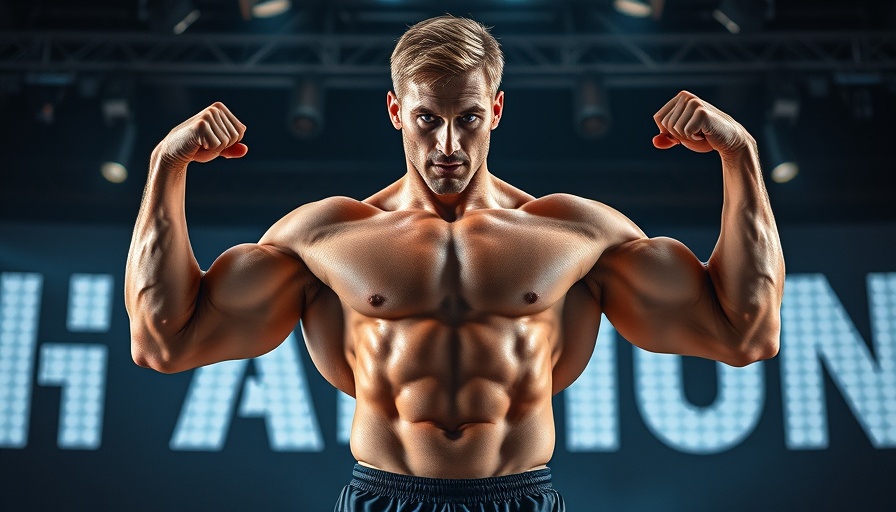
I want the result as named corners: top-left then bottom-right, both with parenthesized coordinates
top-left (0, 0), bottom-right (896, 227)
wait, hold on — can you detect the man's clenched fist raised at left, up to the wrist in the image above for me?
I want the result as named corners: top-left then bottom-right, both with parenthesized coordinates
top-left (157, 102), bottom-right (249, 165)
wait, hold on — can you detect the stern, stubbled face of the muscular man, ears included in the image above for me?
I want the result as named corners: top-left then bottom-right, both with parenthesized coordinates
top-left (387, 70), bottom-right (504, 194)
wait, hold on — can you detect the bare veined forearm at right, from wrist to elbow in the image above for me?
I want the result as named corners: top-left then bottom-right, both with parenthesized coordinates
top-left (707, 142), bottom-right (784, 346)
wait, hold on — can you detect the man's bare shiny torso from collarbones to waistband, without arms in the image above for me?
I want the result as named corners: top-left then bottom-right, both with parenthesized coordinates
top-left (262, 190), bottom-right (620, 478)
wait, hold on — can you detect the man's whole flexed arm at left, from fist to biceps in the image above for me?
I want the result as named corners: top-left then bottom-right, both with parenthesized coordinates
top-left (125, 103), bottom-right (317, 373)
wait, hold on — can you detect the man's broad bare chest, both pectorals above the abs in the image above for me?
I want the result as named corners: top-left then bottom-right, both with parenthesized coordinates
top-left (304, 211), bottom-right (595, 318)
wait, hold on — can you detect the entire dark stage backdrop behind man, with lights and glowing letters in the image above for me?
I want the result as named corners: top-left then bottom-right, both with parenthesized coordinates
top-left (0, 0), bottom-right (896, 511)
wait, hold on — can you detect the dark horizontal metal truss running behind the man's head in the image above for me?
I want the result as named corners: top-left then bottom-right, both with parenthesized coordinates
top-left (0, 32), bottom-right (896, 88)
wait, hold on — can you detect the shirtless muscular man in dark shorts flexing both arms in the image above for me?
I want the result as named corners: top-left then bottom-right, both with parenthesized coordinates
top-left (126, 16), bottom-right (784, 511)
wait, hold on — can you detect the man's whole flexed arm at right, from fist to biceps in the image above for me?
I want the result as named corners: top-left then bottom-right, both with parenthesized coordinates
top-left (601, 91), bottom-right (784, 366)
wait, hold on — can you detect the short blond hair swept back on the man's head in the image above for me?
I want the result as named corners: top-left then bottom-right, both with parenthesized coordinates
top-left (390, 14), bottom-right (504, 98)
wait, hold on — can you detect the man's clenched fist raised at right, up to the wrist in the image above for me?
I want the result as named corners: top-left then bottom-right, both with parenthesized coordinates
top-left (653, 91), bottom-right (756, 155)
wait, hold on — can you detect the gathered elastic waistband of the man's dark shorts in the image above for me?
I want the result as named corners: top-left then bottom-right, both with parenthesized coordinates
top-left (351, 464), bottom-right (553, 503)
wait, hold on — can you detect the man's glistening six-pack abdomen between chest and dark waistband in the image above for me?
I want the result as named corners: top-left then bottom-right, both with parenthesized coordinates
top-left (349, 312), bottom-right (556, 478)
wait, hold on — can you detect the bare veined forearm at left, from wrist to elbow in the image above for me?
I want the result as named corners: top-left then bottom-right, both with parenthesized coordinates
top-left (125, 148), bottom-right (202, 365)
